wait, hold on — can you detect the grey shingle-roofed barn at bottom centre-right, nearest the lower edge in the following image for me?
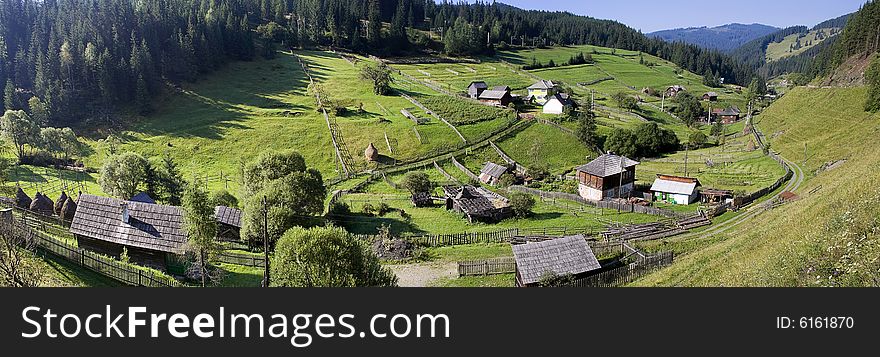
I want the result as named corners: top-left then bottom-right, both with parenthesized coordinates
top-left (513, 235), bottom-right (602, 287)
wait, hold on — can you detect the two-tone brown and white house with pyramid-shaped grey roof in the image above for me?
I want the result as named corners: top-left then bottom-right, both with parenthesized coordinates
top-left (576, 153), bottom-right (639, 201)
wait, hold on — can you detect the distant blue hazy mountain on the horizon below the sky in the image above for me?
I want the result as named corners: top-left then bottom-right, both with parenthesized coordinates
top-left (648, 23), bottom-right (779, 52)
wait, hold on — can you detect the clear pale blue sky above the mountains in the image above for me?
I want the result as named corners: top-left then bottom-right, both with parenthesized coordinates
top-left (470, 0), bottom-right (866, 33)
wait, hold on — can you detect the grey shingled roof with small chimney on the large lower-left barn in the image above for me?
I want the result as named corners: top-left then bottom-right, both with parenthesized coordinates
top-left (70, 194), bottom-right (187, 254)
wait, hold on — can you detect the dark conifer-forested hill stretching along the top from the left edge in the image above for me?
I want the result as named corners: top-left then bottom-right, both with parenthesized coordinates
top-left (0, 0), bottom-right (754, 125)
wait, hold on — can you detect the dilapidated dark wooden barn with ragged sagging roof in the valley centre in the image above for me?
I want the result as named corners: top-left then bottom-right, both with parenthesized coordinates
top-left (443, 186), bottom-right (513, 223)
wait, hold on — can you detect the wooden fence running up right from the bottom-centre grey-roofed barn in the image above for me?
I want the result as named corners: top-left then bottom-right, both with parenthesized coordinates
top-left (562, 252), bottom-right (675, 287)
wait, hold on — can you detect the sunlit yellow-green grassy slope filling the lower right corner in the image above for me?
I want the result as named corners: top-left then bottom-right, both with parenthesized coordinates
top-left (636, 88), bottom-right (880, 286)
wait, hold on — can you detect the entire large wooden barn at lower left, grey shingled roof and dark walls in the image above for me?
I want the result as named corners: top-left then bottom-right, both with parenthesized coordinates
top-left (70, 194), bottom-right (187, 271)
